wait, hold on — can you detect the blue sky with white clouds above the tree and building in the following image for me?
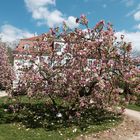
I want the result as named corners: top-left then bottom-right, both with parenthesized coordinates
top-left (0, 0), bottom-right (140, 50)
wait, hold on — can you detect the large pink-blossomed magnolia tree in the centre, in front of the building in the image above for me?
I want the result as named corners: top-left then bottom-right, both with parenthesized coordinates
top-left (14, 15), bottom-right (140, 114)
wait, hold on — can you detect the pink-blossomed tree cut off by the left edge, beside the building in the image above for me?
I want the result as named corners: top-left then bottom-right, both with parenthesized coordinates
top-left (0, 42), bottom-right (13, 91)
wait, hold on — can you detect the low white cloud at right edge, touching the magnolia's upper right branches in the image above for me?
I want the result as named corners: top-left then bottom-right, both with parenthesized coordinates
top-left (116, 30), bottom-right (140, 51)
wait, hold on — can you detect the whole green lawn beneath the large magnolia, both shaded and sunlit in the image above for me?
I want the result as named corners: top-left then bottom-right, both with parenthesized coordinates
top-left (0, 97), bottom-right (121, 140)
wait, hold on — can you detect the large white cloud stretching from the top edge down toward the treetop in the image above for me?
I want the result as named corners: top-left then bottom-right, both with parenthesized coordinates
top-left (24, 0), bottom-right (78, 28)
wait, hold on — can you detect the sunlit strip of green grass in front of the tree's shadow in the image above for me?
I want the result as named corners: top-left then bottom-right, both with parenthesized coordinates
top-left (0, 122), bottom-right (121, 140)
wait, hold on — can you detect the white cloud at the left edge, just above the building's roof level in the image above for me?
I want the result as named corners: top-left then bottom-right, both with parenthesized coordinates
top-left (0, 24), bottom-right (34, 42)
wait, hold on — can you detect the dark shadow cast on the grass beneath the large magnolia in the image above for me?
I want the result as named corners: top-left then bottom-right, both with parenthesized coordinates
top-left (0, 98), bottom-right (120, 131)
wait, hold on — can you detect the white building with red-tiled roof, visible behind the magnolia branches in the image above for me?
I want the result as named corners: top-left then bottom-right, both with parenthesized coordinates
top-left (13, 34), bottom-right (94, 87)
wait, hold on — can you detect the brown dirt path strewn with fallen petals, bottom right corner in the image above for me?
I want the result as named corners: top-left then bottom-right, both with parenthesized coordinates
top-left (78, 116), bottom-right (140, 140)
